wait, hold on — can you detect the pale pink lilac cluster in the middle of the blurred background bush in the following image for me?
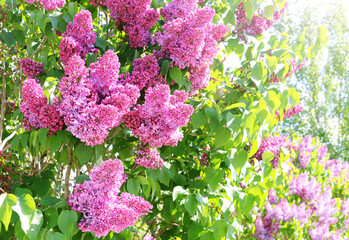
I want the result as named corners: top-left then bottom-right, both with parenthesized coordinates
top-left (289, 172), bottom-right (321, 202)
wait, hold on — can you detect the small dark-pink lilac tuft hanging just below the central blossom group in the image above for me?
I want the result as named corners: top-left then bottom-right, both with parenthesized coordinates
top-left (135, 146), bottom-right (164, 169)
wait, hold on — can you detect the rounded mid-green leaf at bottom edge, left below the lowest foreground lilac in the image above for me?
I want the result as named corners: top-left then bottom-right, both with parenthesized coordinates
top-left (58, 210), bottom-right (78, 238)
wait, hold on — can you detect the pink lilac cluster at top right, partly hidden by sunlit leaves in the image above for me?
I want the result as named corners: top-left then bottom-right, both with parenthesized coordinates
top-left (235, 2), bottom-right (285, 40)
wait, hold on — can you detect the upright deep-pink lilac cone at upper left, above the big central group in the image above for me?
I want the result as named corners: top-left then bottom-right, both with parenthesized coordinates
top-left (59, 10), bottom-right (97, 65)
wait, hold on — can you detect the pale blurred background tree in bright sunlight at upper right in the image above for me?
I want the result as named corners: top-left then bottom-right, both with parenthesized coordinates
top-left (276, 0), bottom-right (349, 161)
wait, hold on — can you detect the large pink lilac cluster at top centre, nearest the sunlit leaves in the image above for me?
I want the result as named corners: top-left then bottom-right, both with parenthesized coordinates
top-left (156, 0), bottom-right (229, 92)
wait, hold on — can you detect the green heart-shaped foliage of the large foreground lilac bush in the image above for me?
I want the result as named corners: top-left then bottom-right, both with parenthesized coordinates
top-left (0, 0), bottom-right (324, 240)
